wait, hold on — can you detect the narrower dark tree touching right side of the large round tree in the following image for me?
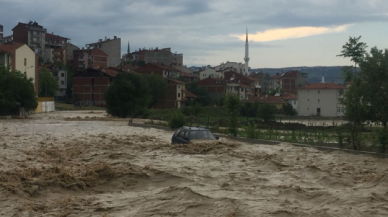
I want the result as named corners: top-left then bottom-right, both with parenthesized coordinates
top-left (143, 74), bottom-right (167, 108)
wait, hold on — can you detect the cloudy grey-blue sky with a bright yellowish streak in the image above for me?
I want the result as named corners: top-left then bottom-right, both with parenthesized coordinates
top-left (0, 0), bottom-right (388, 68)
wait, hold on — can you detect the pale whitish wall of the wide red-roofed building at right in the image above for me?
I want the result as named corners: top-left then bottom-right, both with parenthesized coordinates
top-left (297, 89), bottom-right (343, 117)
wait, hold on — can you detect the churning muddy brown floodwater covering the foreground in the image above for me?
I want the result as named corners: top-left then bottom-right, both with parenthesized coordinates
top-left (0, 111), bottom-right (388, 217)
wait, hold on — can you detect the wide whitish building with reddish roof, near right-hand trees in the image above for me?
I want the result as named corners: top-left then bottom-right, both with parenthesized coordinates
top-left (297, 83), bottom-right (346, 117)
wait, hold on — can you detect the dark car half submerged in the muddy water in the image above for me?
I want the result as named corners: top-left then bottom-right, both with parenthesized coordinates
top-left (171, 127), bottom-right (218, 144)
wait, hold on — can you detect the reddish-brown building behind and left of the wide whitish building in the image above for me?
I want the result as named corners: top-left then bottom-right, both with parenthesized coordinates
top-left (270, 71), bottom-right (307, 94)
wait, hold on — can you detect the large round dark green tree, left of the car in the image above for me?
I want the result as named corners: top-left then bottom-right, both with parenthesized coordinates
top-left (105, 73), bottom-right (151, 118)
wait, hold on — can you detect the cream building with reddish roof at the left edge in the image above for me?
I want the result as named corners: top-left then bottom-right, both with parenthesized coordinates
top-left (0, 43), bottom-right (38, 95)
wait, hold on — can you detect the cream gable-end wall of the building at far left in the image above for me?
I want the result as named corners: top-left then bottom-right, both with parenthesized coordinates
top-left (13, 45), bottom-right (37, 84)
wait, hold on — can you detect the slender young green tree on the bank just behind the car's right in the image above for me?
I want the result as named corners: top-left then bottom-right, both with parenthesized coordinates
top-left (225, 94), bottom-right (241, 136)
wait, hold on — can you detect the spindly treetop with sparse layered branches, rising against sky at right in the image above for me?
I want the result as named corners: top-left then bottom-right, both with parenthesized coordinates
top-left (337, 36), bottom-right (368, 75)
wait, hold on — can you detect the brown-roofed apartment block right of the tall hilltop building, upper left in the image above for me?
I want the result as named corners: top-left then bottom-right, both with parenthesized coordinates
top-left (44, 33), bottom-right (70, 64)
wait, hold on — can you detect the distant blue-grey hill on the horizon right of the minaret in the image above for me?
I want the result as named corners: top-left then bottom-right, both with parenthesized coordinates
top-left (251, 66), bottom-right (344, 83)
